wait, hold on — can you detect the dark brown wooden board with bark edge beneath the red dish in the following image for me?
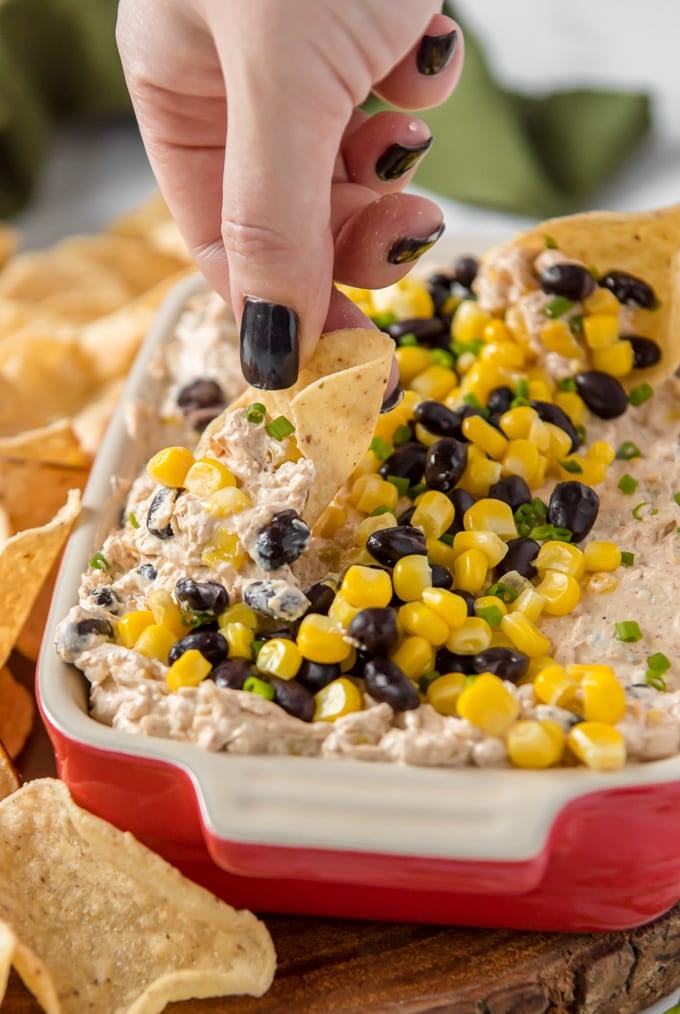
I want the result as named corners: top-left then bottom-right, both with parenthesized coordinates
top-left (3, 659), bottom-right (680, 1014)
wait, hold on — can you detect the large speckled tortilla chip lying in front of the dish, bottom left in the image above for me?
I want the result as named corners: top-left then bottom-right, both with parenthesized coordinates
top-left (0, 779), bottom-right (276, 1014)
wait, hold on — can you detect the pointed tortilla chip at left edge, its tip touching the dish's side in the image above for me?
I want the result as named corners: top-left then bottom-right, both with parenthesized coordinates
top-left (0, 490), bottom-right (80, 666)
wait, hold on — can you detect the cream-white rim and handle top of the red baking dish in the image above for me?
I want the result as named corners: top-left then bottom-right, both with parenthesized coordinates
top-left (39, 236), bottom-right (680, 861)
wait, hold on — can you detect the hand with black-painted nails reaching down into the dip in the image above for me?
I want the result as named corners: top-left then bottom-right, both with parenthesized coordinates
top-left (118, 0), bottom-right (462, 390)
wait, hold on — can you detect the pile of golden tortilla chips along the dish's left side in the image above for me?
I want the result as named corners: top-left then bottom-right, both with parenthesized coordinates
top-left (0, 198), bottom-right (190, 756)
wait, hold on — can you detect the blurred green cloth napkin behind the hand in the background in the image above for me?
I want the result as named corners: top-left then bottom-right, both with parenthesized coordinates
top-left (0, 0), bottom-right (650, 219)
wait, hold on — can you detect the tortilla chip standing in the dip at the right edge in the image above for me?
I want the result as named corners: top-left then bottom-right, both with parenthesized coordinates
top-left (513, 204), bottom-right (680, 383)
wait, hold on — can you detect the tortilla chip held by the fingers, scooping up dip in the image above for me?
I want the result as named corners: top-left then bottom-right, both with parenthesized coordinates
top-left (196, 328), bottom-right (394, 525)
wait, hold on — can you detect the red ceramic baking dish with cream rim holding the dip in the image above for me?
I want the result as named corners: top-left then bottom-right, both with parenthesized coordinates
top-left (37, 239), bottom-right (680, 931)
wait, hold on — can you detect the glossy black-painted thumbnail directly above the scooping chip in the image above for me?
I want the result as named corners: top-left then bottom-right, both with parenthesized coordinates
top-left (241, 296), bottom-right (300, 390)
